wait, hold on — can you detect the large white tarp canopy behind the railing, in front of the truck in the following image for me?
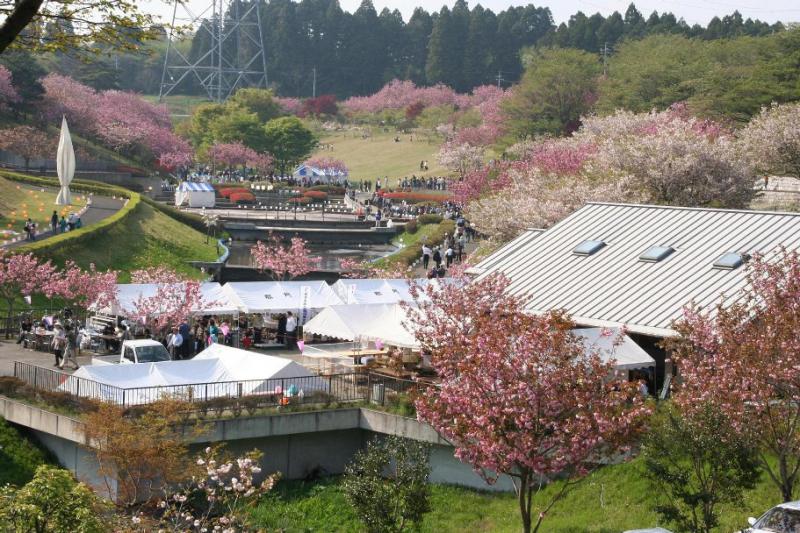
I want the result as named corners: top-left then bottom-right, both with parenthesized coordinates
top-left (59, 344), bottom-right (327, 405)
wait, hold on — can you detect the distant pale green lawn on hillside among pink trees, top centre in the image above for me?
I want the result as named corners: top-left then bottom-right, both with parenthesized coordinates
top-left (314, 128), bottom-right (449, 186)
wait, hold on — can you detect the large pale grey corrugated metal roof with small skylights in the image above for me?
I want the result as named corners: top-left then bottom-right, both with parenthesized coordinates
top-left (477, 203), bottom-right (800, 337)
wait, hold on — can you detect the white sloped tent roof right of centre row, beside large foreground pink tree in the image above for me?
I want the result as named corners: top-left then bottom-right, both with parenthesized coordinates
top-left (303, 304), bottom-right (419, 349)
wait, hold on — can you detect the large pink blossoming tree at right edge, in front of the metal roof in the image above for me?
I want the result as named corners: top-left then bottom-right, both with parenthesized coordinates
top-left (671, 250), bottom-right (800, 501)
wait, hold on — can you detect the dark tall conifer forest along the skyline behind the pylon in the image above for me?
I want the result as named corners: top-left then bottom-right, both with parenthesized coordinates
top-left (19, 0), bottom-right (783, 99)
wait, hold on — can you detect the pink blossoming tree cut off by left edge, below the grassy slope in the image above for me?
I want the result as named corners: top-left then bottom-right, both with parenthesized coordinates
top-left (0, 249), bottom-right (57, 331)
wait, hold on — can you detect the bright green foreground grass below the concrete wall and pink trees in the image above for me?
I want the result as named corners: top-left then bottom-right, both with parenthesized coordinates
top-left (253, 454), bottom-right (780, 533)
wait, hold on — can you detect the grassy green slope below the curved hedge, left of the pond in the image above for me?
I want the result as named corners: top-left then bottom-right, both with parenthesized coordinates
top-left (39, 198), bottom-right (217, 283)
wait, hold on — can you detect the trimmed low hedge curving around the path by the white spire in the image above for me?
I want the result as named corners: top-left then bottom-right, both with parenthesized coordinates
top-left (0, 171), bottom-right (141, 255)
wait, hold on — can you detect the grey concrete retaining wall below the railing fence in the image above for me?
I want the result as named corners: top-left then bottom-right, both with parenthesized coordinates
top-left (0, 397), bottom-right (513, 495)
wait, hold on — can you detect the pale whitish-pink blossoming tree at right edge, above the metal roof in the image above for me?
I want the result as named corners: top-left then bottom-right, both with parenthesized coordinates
top-left (739, 103), bottom-right (800, 177)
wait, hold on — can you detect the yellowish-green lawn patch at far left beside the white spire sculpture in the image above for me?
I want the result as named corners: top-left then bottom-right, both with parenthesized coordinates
top-left (0, 178), bottom-right (86, 241)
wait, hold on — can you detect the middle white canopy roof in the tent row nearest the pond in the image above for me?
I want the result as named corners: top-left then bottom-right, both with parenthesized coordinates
top-left (223, 281), bottom-right (342, 315)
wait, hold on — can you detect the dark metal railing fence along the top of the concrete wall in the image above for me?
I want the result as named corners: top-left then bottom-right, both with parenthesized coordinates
top-left (14, 361), bottom-right (420, 409)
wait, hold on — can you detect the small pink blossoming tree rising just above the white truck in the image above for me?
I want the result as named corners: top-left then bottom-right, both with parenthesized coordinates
top-left (131, 266), bottom-right (205, 333)
